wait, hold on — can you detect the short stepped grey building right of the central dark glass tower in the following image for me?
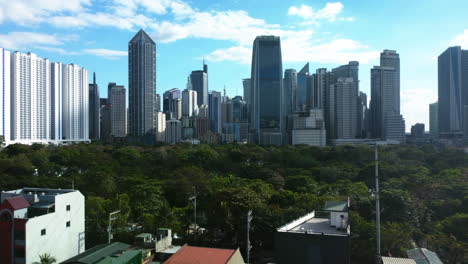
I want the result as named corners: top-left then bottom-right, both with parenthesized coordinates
top-left (291, 109), bottom-right (327, 147)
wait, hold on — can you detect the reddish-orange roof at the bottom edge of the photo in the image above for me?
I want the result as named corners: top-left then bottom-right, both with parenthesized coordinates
top-left (164, 244), bottom-right (236, 264)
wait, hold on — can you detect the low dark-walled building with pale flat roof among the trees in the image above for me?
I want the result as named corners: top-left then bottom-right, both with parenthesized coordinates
top-left (275, 201), bottom-right (351, 264)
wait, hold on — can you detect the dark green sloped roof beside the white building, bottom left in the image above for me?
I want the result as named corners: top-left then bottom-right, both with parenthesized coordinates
top-left (62, 242), bottom-right (130, 264)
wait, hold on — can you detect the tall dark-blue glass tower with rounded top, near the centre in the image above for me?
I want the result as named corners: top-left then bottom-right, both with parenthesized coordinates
top-left (250, 36), bottom-right (284, 145)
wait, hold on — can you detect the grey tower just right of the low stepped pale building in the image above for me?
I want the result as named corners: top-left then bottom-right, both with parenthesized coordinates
top-left (331, 77), bottom-right (357, 139)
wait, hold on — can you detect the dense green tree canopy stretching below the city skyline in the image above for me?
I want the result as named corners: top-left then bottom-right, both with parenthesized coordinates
top-left (0, 144), bottom-right (468, 264)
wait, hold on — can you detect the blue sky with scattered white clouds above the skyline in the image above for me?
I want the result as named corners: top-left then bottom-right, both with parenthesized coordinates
top-left (0, 0), bottom-right (468, 130)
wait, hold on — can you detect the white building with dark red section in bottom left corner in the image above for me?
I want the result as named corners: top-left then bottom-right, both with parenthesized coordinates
top-left (0, 188), bottom-right (85, 264)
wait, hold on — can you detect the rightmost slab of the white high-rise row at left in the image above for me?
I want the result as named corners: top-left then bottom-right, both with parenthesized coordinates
top-left (62, 64), bottom-right (89, 141)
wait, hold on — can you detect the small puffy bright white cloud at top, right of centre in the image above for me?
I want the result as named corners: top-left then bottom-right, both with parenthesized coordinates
top-left (288, 2), bottom-right (344, 23)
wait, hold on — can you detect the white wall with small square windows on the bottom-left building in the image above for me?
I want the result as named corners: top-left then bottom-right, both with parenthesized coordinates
top-left (25, 191), bottom-right (85, 264)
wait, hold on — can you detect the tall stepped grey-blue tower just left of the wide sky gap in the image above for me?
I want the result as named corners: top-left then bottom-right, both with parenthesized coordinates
top-left (371, 50), bottom-right (405, 142)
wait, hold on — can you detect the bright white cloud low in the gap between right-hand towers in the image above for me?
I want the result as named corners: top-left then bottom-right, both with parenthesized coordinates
top-left (400, 88), bottom-right (437, 131)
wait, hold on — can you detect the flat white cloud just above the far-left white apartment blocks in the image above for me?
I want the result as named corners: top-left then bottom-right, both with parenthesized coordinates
top-left (0, 32), bottom-right (63, 50)
